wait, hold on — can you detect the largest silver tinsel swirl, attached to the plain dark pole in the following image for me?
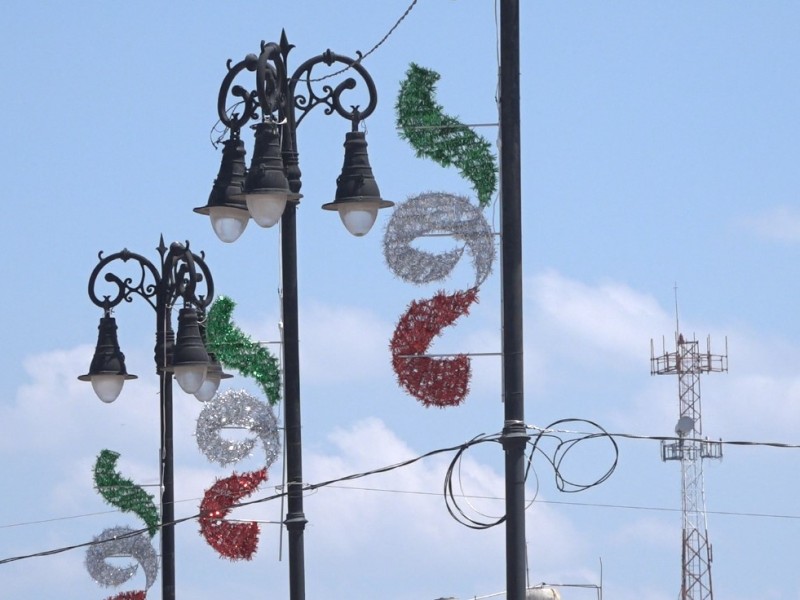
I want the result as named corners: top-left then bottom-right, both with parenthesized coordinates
top-left (383, 192), bottom-right (495, 287)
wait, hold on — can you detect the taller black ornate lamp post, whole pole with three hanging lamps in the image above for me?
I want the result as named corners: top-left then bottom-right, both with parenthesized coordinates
top-left (195, 32), bottom-right (394, 600)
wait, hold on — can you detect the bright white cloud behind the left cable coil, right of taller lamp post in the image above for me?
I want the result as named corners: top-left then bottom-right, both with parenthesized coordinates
top-left (305, 419), bottom-right (583, 597)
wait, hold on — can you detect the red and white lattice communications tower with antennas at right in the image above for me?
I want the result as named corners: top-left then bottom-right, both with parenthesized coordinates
top-left (650, 332), bottom-right (728, 600)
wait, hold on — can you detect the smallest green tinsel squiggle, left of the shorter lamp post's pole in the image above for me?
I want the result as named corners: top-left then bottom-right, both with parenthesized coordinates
top-left (94, 450), bottom-right (160, 537)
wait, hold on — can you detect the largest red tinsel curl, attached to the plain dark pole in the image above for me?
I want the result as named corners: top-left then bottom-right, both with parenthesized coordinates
top-left (390, 288), bottom-right (478, 407)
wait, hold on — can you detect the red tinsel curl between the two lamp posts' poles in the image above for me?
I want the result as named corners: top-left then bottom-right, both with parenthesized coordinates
top-left (199, 468), bottom-right (267, 560)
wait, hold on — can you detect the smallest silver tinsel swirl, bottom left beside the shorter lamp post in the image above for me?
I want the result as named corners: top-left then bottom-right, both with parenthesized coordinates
top-left (86, 527), bottom-right (158, 589)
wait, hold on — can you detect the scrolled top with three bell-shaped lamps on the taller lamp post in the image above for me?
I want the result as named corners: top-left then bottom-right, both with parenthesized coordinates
top-left (194, 32), bottom-right (394, 242)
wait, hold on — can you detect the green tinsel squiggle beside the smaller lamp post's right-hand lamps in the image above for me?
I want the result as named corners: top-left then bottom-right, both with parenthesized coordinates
top-left (206, 296), bottom-right (281, 406)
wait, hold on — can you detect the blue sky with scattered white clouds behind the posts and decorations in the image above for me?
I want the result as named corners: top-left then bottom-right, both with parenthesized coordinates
top-left (0, 0), bottom-right (800, 600)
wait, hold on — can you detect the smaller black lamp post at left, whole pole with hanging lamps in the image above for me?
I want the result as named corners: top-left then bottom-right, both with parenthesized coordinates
top-left (78, 237), bottom-right (220, 600)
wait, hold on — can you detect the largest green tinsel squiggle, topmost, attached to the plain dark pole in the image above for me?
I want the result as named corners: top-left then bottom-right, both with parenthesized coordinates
top-left (395, 63), bottom-right (497, 207)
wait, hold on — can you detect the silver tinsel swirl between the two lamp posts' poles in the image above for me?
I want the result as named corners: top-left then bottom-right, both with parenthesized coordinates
top-left (197, 390), bottom-right (280, 468)
